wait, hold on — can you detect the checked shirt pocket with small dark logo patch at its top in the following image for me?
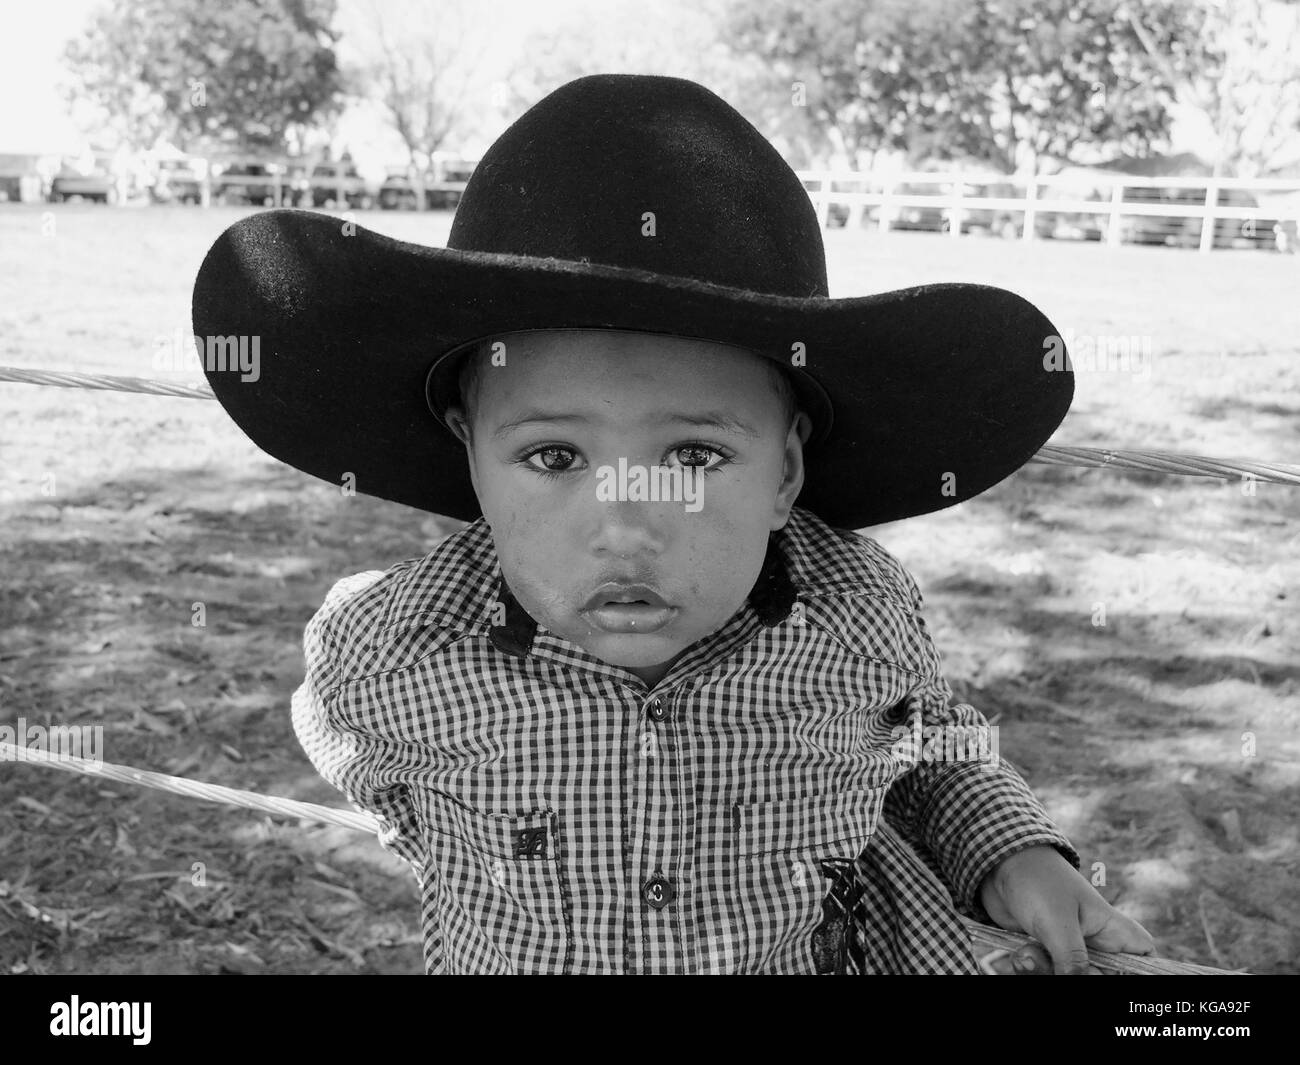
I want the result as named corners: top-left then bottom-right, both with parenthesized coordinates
top-left (420, 791), bottom-right (572, 974)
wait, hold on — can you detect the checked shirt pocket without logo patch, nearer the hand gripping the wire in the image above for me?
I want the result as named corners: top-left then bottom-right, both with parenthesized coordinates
top-left (732, 784), bottom-right (889, 973)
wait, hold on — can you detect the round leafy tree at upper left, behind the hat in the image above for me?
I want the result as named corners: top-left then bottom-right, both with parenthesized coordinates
top-left (65, 0), bottom-right (342, 151)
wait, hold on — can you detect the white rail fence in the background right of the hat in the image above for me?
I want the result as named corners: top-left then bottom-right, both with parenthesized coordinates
top-left (798, 170), bottom-right (1300, 252)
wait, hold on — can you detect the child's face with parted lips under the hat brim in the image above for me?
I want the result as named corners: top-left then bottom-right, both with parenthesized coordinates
top-left (447, 330), bottom-right (810, 685)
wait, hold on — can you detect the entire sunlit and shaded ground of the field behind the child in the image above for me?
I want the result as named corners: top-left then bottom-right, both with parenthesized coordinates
top-left (0, 207), bottom-right (1300, 973)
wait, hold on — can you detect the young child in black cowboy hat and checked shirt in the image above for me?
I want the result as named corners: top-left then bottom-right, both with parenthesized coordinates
top-left (194, 75), bottom-right (1152, 973)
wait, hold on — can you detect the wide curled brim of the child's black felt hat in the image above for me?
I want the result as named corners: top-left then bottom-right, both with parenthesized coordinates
top-left (192, 211), bottom-right (1074, 528)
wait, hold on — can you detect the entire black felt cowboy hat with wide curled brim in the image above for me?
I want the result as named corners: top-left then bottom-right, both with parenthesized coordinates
top-left (194, 74), bottom-right (1074, 528)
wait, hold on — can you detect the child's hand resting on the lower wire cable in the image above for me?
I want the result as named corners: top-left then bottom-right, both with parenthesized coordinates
top-left (979, 847), bottom-right (1156, 975)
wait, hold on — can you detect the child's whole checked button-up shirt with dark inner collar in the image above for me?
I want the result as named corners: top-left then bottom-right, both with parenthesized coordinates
top-left (293, 507), bottom-right (1079, 974)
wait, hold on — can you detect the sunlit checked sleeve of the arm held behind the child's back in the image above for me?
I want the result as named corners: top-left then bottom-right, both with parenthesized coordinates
top-left (293, 571), bottom-right (424, 875)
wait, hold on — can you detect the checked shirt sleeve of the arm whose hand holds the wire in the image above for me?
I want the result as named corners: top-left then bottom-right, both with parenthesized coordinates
top-left (885, 567), bottom-right (1079, 921)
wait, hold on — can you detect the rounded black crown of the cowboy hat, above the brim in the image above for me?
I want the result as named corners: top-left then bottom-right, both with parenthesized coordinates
top-left (447, 74), bottom-right (828, 298)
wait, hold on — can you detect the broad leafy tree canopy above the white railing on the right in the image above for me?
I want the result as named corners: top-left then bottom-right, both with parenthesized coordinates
top-left (729, 0), bottom-right (1200, 172)
